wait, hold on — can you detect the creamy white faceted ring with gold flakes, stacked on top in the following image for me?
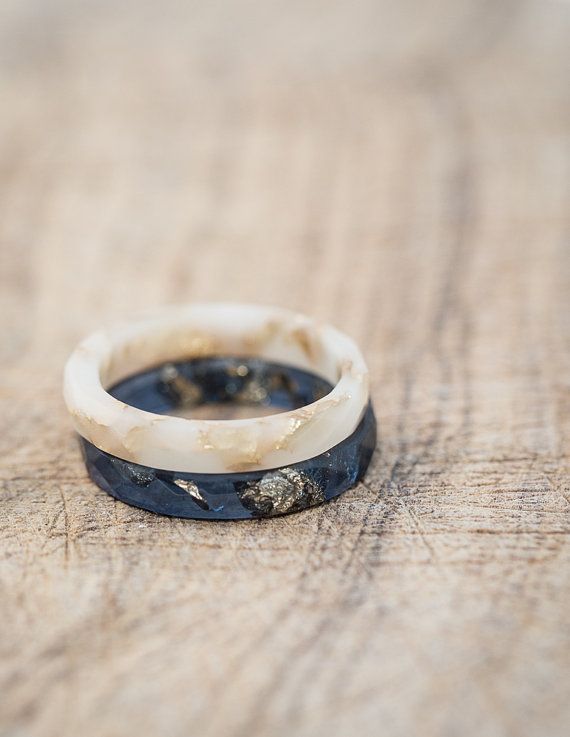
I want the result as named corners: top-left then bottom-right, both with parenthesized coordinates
top-left (64, 304), bottom-right (368, 473)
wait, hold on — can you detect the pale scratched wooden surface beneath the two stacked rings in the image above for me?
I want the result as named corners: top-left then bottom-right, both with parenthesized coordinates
top-left (0, 0), bottom-right (570, 737)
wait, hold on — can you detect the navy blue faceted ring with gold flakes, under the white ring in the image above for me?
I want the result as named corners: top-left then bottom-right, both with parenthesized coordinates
top-left (81, 358), bottom-right (376, 520)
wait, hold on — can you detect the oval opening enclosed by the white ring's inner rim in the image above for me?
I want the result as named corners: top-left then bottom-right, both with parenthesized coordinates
top-left (109, 357), bottom-right (333, 420)
